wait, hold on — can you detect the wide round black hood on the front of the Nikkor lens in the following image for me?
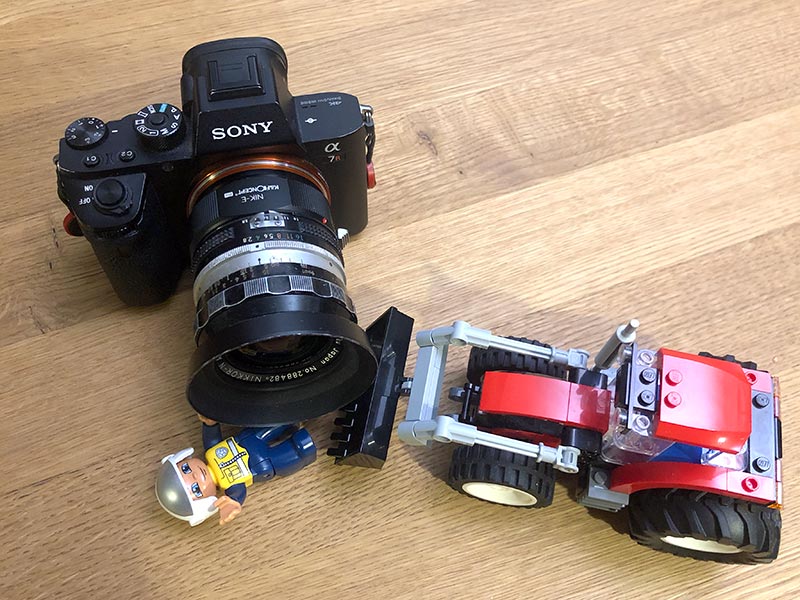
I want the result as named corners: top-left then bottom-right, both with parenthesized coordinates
top-left (187, 296), bottom-right (377, 426)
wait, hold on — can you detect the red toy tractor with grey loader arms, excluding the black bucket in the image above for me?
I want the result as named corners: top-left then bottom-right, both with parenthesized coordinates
top-left (398, 320), bottom-right (782, 563)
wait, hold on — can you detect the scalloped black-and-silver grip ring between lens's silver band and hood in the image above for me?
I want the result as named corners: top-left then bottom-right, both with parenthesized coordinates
top-left (194, 275), bottom-right (356, 339)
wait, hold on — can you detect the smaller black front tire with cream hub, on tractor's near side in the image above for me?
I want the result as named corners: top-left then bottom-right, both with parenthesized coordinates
top-left (447, 444), bottom-right (556, 508)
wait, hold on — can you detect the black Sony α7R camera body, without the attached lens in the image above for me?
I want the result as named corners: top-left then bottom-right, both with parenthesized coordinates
top-left (56, 38), bottom-right (374, 305)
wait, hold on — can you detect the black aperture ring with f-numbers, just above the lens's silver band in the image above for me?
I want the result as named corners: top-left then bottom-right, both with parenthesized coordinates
top-left (191, 212), bottom-right (344, 274)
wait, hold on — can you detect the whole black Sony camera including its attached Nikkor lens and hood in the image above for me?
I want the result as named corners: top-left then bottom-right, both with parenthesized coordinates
top-left (56, 38), bottom-right (410, 432)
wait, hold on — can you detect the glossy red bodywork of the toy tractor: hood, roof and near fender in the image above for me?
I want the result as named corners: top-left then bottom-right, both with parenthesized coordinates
top-left (478, 349), bottom-right (780, 504)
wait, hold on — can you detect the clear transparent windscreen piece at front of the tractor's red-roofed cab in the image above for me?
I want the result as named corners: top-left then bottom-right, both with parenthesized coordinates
top-left (602, 407), bottom-right (674, 465)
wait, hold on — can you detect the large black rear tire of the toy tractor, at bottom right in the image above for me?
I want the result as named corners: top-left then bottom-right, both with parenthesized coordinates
top-left (628, 489), bottom-right (781, 564)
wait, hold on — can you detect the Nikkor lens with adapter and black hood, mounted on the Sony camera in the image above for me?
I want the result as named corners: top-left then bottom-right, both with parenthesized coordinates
top-left (188, 156), bottom-right (377, 425)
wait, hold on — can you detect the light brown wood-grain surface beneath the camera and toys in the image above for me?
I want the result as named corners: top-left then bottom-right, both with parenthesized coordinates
top-left (0, 0), bottom-right (800, 600)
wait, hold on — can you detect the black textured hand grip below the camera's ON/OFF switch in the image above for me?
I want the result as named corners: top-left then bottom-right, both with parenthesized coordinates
top-left (86, 190), bottom-right (186, 306)
